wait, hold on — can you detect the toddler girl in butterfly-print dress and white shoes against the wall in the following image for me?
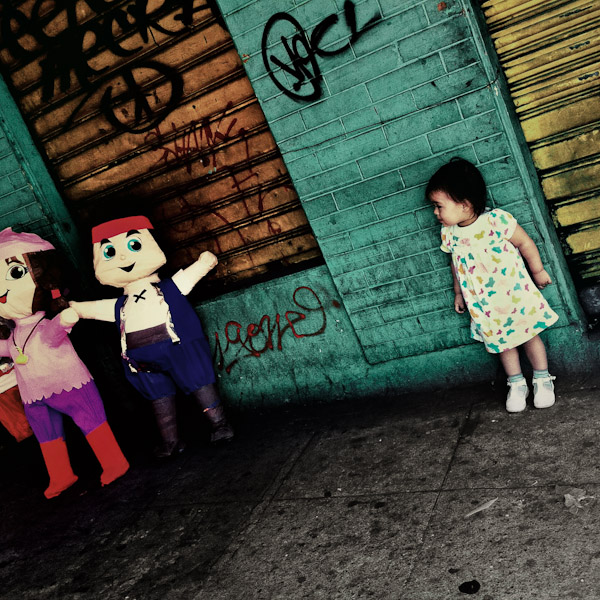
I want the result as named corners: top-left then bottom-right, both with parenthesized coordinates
top-left (425, 158), bottom-right (558, 412)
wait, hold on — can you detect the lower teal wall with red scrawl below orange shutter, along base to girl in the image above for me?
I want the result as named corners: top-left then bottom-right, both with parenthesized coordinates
top-left (197, 266), bottom-right (497, 408)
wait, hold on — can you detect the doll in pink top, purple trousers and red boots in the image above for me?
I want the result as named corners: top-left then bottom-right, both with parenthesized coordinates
top-left (0, 227), bottom-right (129, 498)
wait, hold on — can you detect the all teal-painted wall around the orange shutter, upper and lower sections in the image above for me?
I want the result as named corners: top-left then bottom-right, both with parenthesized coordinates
top-left (0, 0), bottom-right (598, 406)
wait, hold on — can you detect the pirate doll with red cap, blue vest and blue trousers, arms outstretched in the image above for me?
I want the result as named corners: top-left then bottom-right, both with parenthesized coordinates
top-left (70, 216), bottom-right (233, 458)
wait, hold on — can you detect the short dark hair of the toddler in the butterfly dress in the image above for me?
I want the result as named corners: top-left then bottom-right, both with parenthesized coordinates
top-left (425, 158), bottom-right (487, 216)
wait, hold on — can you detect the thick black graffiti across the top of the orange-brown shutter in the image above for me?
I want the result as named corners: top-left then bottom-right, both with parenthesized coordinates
top-left (0, 0), bottom-right (224, 133)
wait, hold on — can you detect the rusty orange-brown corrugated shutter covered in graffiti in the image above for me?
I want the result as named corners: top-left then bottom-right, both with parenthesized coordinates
top-left (0, 0), bottom-right (322, 291)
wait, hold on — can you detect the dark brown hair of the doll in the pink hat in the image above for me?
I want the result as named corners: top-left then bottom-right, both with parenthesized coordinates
top-left (23, 250), bottom-right (72, 318)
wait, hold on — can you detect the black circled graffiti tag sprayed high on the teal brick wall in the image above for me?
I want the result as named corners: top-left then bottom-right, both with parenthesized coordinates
top-left (261, 0), bottom-right (381, 102)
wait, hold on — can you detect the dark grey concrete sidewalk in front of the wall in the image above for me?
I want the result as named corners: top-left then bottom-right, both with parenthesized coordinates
top-left (0, 380), bottom-right (600, 600)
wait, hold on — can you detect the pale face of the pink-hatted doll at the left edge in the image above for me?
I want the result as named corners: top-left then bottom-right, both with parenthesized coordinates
top-left (0, 254), bottom-right (35, 319)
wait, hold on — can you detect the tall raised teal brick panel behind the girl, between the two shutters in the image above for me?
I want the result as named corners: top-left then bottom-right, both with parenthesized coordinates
top-left (219, 0), bottom-right (578, 364)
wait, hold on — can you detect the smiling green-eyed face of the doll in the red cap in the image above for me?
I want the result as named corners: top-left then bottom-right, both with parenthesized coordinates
top-left (94, 219), bottom-right (167, 288)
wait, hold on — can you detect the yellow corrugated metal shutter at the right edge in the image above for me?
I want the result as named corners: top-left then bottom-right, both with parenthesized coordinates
top-left (481, 0), bottom-right (600, 316)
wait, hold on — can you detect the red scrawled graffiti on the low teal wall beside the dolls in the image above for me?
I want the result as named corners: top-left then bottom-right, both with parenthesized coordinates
top-left (213, 286), bottom-right (327, 374)
